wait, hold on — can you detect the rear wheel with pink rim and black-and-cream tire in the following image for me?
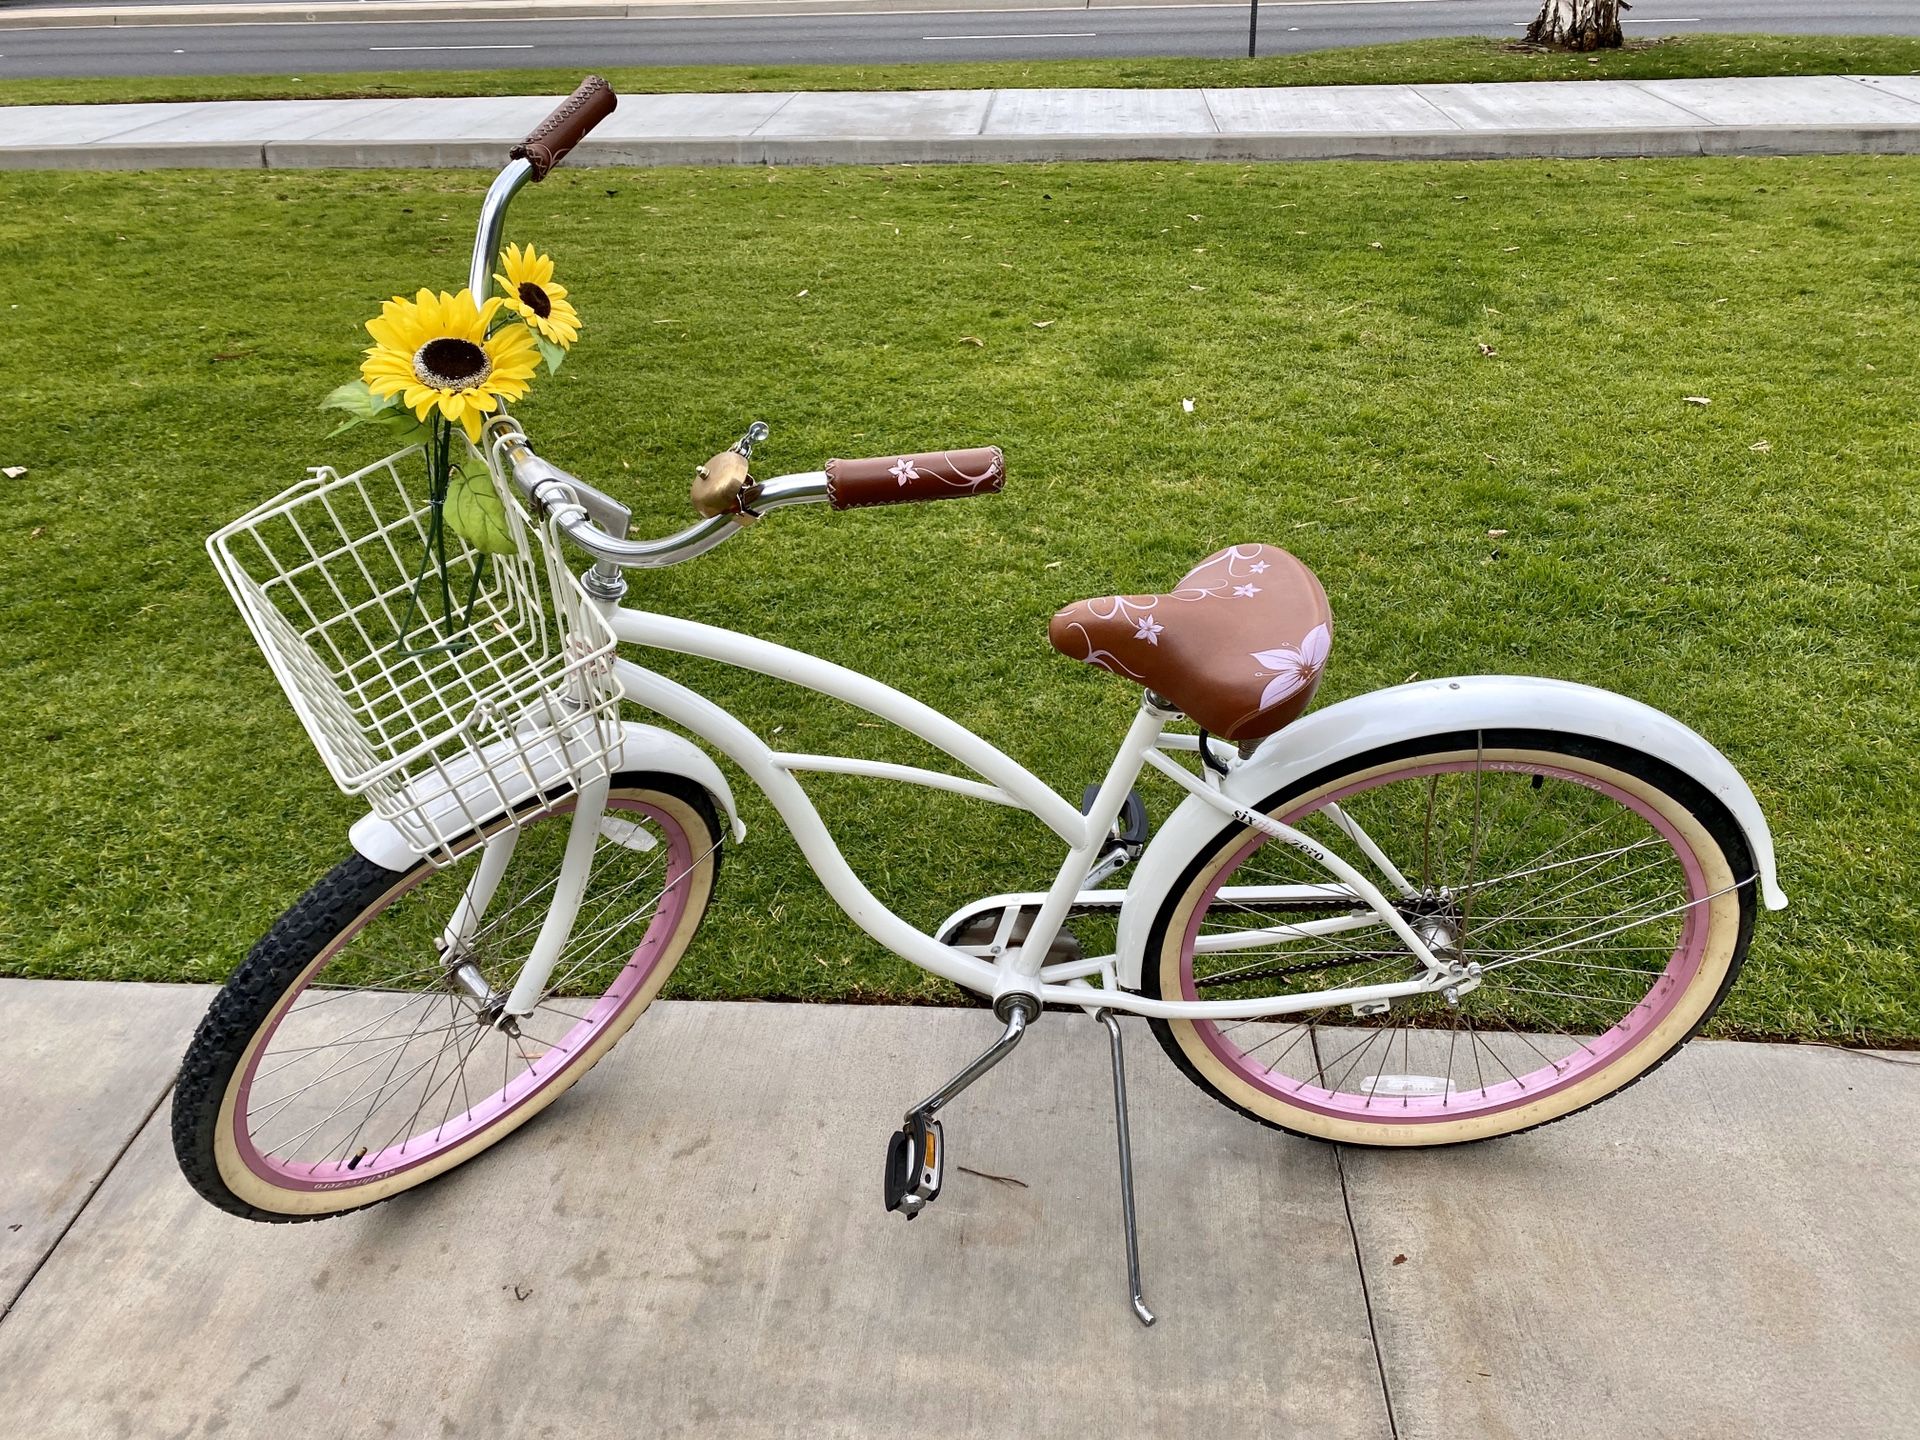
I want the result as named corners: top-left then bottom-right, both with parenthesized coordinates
top-left (1142, 730), bottom-right (1755, 1146)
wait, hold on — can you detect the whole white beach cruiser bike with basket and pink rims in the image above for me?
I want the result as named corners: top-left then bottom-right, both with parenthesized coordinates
top-left (173, 81), bottom-right (1786, 1323)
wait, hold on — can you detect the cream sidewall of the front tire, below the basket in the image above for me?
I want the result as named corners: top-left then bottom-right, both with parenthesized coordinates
top-left (213, 787), bottom-right (716, 1215)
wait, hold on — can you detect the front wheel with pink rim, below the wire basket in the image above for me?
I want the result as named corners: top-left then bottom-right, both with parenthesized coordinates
top-left (173, 774), bottom-right (722, 1221)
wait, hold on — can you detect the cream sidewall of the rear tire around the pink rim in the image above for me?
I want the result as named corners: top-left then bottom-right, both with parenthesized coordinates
top-left (1156, 749), bottom-right (1741, 1146)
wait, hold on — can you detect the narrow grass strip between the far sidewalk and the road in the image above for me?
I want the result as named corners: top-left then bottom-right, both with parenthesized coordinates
top-left (11, 35), bottom-right (1920, 106)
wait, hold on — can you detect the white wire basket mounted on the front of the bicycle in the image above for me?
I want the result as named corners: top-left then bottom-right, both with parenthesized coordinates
top-left (207, 445), bottom-right (620, 862)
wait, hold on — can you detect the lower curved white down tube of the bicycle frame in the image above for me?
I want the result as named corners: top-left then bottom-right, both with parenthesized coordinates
top-left (612, 660), bottom-right (995, 995)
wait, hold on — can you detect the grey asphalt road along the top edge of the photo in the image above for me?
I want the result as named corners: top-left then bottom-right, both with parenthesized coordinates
top-left (0, 0), bottom-right (1920, 79)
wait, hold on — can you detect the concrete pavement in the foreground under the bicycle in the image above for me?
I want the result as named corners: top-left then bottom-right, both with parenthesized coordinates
top-left (0, 981), bottom-right (1920, 1440)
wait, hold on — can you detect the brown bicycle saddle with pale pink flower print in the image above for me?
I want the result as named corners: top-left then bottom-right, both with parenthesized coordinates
top-left (1046, 545), bottom-right (1332, 741)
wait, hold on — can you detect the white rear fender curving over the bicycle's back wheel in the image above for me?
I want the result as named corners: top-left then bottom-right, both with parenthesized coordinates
top-left (1116, 676), bottom-right (1788, 991)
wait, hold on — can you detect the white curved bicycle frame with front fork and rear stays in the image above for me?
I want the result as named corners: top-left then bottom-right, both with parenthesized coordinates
top-left (472, 603), bottom-right (1476, 1020)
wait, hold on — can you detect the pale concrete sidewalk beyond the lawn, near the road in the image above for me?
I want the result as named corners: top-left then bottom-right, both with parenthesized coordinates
top-left (11, 75), bottom-right (1920, 169)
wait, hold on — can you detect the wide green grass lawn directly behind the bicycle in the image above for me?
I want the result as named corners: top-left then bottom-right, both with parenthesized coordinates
top-left (0, 157), bottom-right (1920, 1043)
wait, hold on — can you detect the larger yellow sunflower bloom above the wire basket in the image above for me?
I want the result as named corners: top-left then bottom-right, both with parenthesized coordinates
top-left (361, 290), bottom-right (540, 440)
